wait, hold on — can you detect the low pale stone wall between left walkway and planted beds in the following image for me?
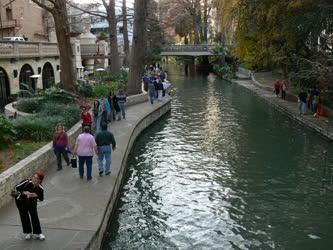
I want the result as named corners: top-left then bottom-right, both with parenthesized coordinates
top-left (0, 93), bottom-right (148, 208)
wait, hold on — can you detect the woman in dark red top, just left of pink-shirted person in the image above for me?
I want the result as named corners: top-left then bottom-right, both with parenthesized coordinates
top-left (53, 123), bottom-right (69, 171)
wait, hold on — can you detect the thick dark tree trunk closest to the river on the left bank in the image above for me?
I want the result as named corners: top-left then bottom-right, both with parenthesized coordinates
top-left (127, 0), bottom-right (150, 94)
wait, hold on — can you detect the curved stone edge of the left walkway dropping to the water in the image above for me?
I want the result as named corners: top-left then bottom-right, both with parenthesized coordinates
top-left (86, 100), bottom-right (171, 249)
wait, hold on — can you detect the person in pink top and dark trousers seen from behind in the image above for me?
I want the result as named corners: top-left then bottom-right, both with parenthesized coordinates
top-left (74, 127), bottom-right (98, 181)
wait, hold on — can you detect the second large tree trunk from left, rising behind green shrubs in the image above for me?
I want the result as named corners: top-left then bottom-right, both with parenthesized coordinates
top-left (107, 0), bottom-right (120, 73)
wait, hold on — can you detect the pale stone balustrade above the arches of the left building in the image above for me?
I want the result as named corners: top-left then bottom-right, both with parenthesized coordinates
top-left (0, 41), bottom-right (59, 59)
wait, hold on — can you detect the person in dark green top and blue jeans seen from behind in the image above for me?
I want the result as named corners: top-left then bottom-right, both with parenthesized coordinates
top-left (95, 123), bottom-right (116, 176)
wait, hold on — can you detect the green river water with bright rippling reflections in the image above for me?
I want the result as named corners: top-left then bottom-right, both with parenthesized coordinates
top-left (103, 69), bottom-right (333, 250)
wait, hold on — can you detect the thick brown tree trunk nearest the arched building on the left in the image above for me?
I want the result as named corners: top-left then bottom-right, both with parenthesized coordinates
top-left (52, 0), bottom-right (77, 92)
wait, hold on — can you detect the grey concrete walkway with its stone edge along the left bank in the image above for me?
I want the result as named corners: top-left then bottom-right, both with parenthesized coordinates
top-left (0, 97), bottom-right (171, 249)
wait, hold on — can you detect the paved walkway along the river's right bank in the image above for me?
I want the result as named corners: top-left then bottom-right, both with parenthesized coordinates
top-left (233, 77), bottom-right (333, 141)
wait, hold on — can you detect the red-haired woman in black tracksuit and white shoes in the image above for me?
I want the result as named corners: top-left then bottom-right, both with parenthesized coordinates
top-left (15, 171), bottom-right (45, 240)
